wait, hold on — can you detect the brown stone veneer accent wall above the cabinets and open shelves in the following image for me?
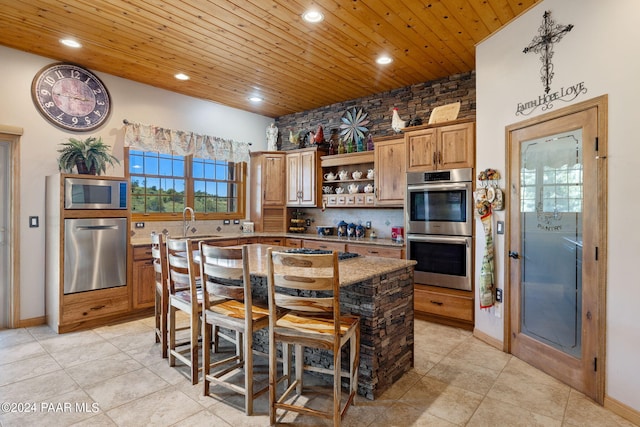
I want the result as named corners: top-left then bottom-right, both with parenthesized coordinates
top-left (275, 71), bottom-right (476, 150)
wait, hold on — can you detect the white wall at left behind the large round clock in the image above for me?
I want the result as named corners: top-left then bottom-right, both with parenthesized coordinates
top-left (0, 46), bottom-right (273, 319)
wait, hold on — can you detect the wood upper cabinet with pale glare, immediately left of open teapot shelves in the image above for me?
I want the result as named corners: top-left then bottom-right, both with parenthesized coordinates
top-left (286, 147), bottom-right (321, 207)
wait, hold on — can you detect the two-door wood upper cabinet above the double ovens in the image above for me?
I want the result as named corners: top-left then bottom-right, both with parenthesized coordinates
top-left (404, 120), bottom-right (475, 172)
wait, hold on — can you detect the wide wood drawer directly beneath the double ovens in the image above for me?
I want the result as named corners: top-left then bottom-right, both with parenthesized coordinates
top-left (414, 285), bottom-right (473, 322)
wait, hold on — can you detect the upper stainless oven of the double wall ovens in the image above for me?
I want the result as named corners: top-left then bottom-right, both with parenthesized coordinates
top-left (405, 182), bottom-right (473, 236)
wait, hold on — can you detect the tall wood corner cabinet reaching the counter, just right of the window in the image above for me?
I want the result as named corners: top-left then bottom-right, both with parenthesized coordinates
top-left (249, 151), bottom-right (286, 232)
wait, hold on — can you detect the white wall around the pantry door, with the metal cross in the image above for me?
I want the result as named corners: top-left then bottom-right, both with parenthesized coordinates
top-left (476, 0), bottom-right (640, 410)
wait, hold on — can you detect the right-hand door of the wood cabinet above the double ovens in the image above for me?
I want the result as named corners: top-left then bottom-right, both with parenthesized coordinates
top-left (438, 123), bottom-right (475, 169)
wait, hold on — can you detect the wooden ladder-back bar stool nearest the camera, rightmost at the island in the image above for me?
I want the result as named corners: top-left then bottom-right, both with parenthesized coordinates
top-left (267, 248), bottom-right (360, 426)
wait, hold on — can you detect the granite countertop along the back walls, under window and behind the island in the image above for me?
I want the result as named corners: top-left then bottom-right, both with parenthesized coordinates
top-left (131, 232), bottom-right (404, 248)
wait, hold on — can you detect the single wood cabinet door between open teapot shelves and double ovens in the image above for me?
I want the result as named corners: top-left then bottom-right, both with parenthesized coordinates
top-left (375, 139), bottom-right (406, 206)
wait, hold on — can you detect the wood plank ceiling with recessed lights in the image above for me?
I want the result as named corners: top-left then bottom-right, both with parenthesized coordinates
top-left (0, 0), bottom-right (540, 117)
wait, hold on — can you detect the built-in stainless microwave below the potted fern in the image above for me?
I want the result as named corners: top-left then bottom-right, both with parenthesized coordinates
top-left (64, 177), bottom-right (128, 209)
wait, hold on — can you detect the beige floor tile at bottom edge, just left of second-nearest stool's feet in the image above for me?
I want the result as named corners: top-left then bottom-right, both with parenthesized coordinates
top-left (107, 388), bottom-right (202, 426)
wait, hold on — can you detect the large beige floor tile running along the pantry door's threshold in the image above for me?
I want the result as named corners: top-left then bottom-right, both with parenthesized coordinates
top-left (487, 358), bottom-right (570, 420)
